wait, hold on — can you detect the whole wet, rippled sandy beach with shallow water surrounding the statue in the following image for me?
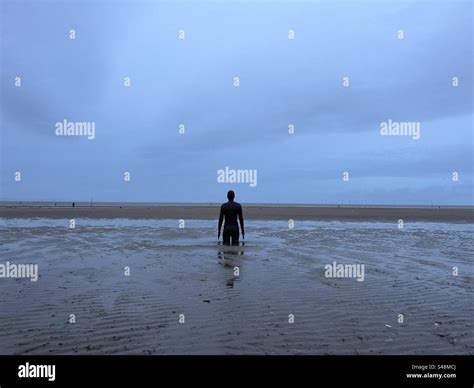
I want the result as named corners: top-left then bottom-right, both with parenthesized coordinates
top-left (0, 212), bottom-right (474, 355)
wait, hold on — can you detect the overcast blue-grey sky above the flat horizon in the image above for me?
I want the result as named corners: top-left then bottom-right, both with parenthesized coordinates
top-left (0, 0), bottom-right (474, 205)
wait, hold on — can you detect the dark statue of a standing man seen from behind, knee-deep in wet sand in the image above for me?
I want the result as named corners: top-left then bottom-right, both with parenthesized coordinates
top-left (217, 190), bottom-right (245, 245)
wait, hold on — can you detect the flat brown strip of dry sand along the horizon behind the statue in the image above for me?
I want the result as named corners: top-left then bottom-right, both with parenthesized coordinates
top-left (0, 203), bottom-right (474, 223)
